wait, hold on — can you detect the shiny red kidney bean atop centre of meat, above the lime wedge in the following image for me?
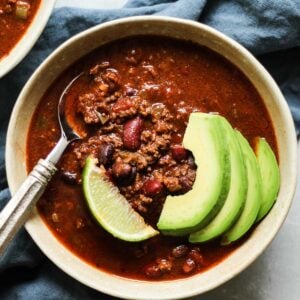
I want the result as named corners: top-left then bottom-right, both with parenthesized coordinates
top-left (123, 117), bottom-right (143, 151)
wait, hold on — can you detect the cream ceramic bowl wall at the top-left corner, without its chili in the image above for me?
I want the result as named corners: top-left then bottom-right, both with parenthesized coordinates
top-left (0, 0), bottom-right (56, 78)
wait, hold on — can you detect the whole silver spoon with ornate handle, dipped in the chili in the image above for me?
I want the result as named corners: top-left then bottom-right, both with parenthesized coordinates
top-left (0, 73), bottom-right (83, 255)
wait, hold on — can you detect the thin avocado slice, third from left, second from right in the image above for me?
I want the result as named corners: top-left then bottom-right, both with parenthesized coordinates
top-left (221, 131), bottom-right (262, 245)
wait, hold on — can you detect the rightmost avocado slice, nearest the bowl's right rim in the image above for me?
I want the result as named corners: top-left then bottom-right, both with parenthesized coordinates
top-left (255, 138), bottom-right (280, 222)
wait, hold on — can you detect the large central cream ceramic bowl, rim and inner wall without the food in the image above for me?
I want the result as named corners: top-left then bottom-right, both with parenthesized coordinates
top-left (6, 16), bottom-right (297, 299)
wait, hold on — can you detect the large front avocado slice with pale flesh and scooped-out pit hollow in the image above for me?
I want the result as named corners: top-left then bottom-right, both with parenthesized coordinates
top-left (157, 112), bottom-right (230, 236)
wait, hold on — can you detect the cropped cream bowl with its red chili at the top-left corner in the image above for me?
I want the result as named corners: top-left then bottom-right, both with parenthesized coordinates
top-left (0, 0), bottom-right (55, 78)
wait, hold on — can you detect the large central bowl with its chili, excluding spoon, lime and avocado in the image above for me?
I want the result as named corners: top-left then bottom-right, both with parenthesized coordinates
top-left (6, 16), bottom-right (297, 299)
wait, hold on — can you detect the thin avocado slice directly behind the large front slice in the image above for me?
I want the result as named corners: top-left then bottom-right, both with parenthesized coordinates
top-left (189, 116), bottom-right (247, 243)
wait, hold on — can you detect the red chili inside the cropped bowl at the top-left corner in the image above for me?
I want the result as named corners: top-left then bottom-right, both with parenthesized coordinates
top-left (0, 0), bottom-right (41, 59)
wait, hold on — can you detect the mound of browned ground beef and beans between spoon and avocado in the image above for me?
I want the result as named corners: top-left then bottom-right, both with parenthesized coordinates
top-left (69, 61), bottom-right (196, 216)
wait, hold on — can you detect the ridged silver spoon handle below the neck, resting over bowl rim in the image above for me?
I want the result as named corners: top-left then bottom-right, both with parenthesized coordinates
top-left (0, 159), bottom-right (57, 255)
